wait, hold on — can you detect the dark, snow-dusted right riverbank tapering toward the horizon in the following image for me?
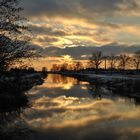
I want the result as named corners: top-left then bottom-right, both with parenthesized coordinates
top-left (49, 72), bottom-right (140, 100)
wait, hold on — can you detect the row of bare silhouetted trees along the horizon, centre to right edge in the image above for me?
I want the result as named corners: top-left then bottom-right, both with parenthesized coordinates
top-left (51, 51), bottom-right (140, 73)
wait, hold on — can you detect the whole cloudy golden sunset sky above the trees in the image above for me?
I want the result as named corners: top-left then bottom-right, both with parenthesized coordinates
top-left (21, 0), bottom-right (140, 67)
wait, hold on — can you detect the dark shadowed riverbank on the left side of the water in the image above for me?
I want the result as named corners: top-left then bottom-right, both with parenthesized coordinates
top-left (0, 70), bottom-right (45, 115)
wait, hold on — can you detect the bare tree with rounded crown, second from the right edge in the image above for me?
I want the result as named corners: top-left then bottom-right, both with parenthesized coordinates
top-left (119, 54), bottom-right (130, 70)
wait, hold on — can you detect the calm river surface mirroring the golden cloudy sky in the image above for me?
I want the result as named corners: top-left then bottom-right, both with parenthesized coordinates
top-left (22, 75), bottom-right (140, 140)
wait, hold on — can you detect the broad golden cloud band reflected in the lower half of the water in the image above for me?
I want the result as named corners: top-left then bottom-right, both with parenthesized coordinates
top-left (25, 96), bottom-right (140, 128)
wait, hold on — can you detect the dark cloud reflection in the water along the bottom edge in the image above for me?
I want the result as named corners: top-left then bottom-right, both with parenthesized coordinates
top-left (30, 125), bottom-right (140, 140)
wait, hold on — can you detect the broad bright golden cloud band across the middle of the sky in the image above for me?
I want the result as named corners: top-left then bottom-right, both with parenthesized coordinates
top-left (30, 18), bottom-right (140, 48)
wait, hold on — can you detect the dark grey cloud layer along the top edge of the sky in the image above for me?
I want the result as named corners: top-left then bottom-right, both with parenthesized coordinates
top-left (22, 0), bottom-right (139, 19)
